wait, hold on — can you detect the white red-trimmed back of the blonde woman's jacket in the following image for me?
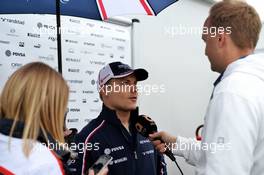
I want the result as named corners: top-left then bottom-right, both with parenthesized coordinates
top-left (0, 134), bottom-right (64, 175)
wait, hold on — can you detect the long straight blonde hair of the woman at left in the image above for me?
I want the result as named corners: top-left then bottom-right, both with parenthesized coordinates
top-left (0, 62), bottom-right (69, 156)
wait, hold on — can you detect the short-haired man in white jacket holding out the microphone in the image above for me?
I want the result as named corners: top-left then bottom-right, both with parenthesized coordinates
top-left (150, 1), bottom-right (264, 175)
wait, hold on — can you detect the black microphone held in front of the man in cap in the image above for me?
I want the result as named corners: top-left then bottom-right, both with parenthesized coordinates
top-left (135, 115), bottom-right (176, 161)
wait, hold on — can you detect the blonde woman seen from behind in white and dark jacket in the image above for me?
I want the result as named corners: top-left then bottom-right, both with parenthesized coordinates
top-left (0, 62), bottom-right (107, 175)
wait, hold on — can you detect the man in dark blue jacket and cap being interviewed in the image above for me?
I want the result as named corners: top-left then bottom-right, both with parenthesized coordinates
top-left (76, 62), bottom-right (167, 175)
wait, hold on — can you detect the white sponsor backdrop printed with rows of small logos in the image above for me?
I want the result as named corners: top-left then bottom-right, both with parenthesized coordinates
top-left (0, 14), bottom-right (132, 130)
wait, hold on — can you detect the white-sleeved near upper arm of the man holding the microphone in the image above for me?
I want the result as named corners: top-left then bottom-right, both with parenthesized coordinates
top-left (197, 93), bottom-right (260, 175)
